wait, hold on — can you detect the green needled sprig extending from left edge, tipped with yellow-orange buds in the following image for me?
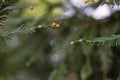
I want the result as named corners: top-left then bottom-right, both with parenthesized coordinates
top-left (0, 23), bottom-right (60, 37)
